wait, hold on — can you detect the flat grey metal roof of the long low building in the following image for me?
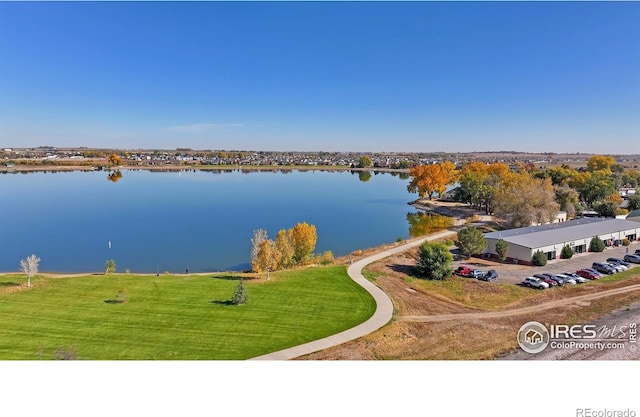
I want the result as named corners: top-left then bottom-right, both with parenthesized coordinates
top-left (484, 218), bottom-right (640, 249)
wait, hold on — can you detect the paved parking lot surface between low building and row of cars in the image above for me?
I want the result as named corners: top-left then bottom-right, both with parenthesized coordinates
top-left (454, 242), bottom-right (640, 284)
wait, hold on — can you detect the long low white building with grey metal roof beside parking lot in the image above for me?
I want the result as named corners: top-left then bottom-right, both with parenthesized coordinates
top-left (483, 218), bottom-right (640, 264)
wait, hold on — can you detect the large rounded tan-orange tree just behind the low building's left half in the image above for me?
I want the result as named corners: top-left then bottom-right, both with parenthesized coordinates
top-left (493, 173), bottom-right (559, 227)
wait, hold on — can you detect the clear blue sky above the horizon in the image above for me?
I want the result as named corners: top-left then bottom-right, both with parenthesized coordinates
top-left (0, 2), bottom-right (640, 153)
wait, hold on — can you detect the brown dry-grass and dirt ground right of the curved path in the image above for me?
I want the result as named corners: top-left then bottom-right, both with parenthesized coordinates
top-left (299, 245), bottom-right (640, 360)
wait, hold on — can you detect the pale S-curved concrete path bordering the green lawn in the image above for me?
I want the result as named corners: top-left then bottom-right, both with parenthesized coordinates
top-left (251, 230), bottom-right (455, 360)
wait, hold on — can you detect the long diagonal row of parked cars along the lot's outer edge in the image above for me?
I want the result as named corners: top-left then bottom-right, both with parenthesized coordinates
top-left (522, 249), bottom-right (640, 290)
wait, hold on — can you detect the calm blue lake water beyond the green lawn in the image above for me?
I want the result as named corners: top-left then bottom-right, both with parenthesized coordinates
top-left (0, 171), bottom-right (436, 273)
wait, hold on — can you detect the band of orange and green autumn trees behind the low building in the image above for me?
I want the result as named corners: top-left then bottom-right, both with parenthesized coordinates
top-left (407, 155), bottom-right (640, 227)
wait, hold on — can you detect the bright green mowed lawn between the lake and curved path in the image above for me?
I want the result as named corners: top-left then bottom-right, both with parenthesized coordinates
top-left (0, 266), bottom-right (375, 360)
